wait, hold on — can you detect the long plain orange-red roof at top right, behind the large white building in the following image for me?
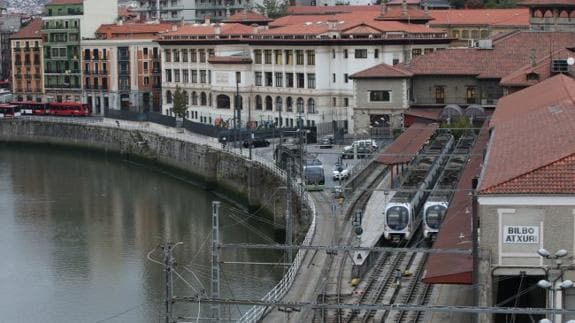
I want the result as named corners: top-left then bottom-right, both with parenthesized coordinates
top-left (429, 8), bottom-right (529, 28)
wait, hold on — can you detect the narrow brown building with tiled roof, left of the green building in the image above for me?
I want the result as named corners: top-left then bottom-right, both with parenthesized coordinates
top-left (10, 19), bottom-right (44, 101)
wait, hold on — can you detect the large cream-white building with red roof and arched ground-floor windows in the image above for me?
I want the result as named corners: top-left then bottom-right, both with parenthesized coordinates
top-left (158, 11), bottom-right (450, 133)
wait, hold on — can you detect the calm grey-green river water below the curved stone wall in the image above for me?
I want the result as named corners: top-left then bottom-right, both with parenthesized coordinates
top-left (0, 147), bottom-right (281, 322)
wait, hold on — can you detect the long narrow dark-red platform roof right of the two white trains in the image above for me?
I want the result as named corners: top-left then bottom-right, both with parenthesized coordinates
top-left (422, 122), bottom-right (489, 284)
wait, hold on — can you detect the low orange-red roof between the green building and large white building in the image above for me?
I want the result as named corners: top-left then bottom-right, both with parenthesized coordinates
top-left (96, 23), bottom-right (173, 39)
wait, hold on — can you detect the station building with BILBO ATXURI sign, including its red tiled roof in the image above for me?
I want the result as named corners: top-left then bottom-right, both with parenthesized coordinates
top-left (476, 74), bottom-right (575, 322)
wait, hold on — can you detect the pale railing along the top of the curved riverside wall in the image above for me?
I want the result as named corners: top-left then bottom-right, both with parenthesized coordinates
top-left (9, 116), bottom-right (317, 322)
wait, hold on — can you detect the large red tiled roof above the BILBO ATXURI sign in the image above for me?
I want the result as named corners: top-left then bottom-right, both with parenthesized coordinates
top-left (480, 75), bottom-right (575, 194)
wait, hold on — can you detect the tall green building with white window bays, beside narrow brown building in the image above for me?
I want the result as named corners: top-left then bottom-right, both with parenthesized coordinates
top-left (42, 0), bottom-right (84, 102)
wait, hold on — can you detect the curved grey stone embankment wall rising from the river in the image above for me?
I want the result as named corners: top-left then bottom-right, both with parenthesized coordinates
top-left (0, 119), bottom-right (300, 228)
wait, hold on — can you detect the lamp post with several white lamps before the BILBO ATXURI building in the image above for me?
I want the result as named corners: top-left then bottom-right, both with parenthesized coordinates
top-left (537, 248), bottom-right (575, 323)
